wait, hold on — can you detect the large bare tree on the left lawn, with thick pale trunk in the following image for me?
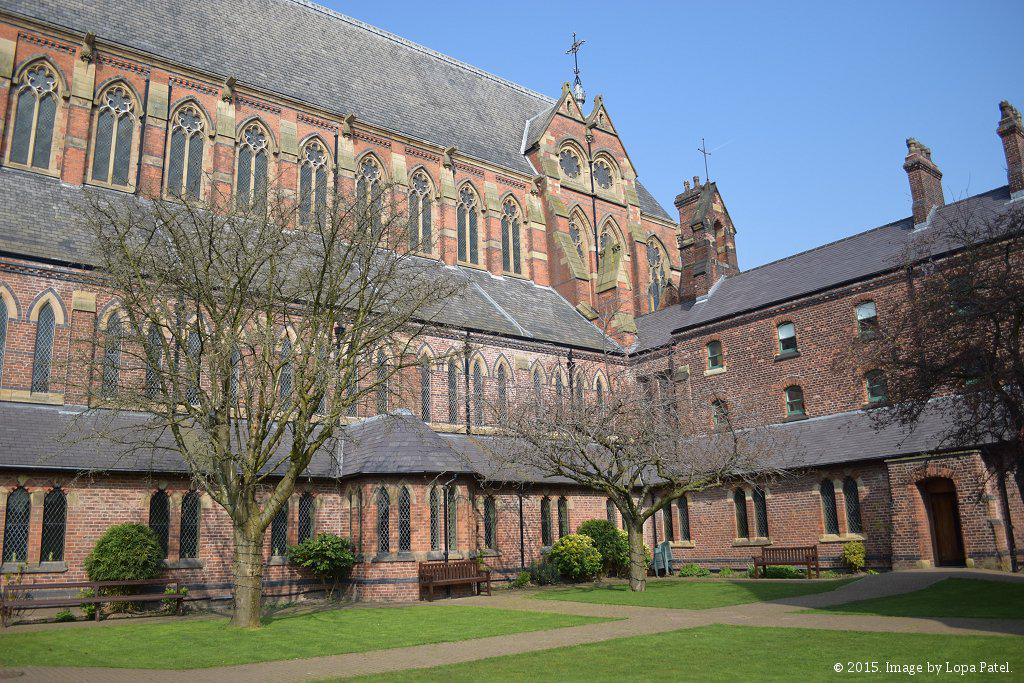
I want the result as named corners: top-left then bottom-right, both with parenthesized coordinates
top-left (72, 183), bottom-right (461, 628)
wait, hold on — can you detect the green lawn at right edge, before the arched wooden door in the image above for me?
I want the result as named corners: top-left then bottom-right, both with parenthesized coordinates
top-left (813, 579), bottom-right (1024, 618)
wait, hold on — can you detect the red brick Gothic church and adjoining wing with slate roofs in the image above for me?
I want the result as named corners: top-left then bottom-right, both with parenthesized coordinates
top-left (0, 0), bottom-right (1024, 599)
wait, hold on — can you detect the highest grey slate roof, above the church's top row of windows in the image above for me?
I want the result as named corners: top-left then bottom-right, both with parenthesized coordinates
top-left (0, 0), bottom-right (665, 216)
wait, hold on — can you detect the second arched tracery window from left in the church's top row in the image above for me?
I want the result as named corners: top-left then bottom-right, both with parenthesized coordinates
top-left (92, 84), bottom-right (136, 187)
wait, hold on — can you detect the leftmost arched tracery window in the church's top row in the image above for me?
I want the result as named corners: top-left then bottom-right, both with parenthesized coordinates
top-left (9, 63), bottom-right (57, 169)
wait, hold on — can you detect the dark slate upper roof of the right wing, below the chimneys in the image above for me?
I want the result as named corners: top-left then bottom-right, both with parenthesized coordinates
top-left (634, 185), bottom-right (1010, 351)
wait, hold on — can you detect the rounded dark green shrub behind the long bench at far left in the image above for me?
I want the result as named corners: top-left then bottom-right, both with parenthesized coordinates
top-left (85, 524), bottom-right (164, 581)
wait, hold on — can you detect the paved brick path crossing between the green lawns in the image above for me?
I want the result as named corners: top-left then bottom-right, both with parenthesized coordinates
top-left (0, 569), bottom-right (1024, 683)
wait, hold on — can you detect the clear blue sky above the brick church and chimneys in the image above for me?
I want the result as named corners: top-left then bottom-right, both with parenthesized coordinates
top-left (326, 0), bottom-right (1024, 268)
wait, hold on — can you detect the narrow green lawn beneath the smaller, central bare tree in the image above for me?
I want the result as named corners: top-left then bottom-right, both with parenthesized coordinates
top-left (535, 579), bottom-right (851, 609)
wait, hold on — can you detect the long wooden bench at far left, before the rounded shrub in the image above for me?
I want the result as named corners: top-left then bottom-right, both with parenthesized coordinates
top-left (0, 579), bottom-right (185, 628)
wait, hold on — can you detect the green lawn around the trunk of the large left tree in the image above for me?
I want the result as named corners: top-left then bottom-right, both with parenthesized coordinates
top-left (0, 605), bottom-right (604, 669)
